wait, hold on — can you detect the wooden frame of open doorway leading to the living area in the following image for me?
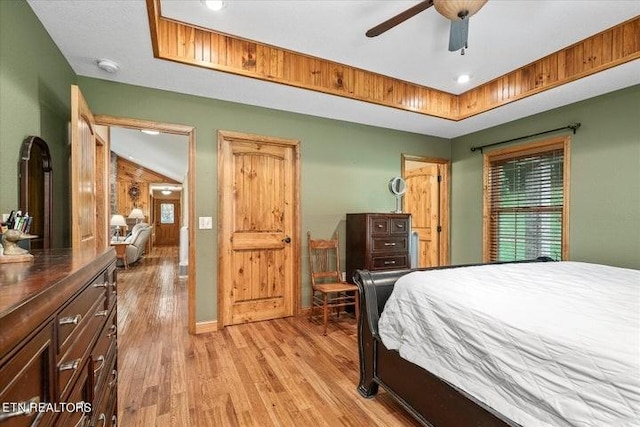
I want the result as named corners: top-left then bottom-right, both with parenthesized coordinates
top-left (94, 115), bottom-right (196, 334)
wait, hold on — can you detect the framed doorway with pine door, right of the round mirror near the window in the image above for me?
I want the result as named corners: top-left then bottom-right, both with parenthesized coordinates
top-left (402, 154), bottom-right (451, 267)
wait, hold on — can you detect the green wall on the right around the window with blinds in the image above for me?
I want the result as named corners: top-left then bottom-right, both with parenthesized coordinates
top-left (451, 86), bottom-right (640, 268)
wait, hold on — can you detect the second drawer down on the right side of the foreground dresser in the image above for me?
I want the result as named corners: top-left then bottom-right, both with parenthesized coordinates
top-left (57, 294), bottom-right (107, 401)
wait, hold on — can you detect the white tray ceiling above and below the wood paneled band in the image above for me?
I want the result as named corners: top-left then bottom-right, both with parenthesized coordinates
top-left (28, 0), bottom-right (640, 144)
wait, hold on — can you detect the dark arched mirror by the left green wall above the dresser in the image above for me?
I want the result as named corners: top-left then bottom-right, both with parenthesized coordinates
top-left (18, 136), bottom-right (53, 249)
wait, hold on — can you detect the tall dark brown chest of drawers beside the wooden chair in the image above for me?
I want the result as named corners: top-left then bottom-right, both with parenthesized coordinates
top-left (346, 213), bottom-right (411, 282)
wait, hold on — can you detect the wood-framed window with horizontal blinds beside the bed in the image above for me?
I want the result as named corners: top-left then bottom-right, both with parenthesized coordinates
top-left (483, 137), bottom-right (569, 261)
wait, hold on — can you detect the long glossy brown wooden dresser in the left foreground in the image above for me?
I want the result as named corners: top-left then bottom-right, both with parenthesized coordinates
top-left (0, 248), bottom-right (117, 427)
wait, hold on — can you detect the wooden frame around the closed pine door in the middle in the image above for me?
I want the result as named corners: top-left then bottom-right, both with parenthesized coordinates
top-left (217, 130), bottom-right (302, 330)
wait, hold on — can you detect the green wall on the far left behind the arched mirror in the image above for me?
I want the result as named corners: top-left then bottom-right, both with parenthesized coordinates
top-left (0, 1), bottom-right (76, 247)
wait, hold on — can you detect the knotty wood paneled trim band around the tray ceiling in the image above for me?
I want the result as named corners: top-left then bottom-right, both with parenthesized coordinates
top-left (147, 0), bottom-right (640, 121)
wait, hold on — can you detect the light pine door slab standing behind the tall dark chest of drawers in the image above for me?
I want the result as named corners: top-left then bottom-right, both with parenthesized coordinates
top-left (404, 163), bottom-right (443, 267)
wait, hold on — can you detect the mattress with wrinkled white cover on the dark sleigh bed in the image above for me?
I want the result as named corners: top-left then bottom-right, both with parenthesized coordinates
top-left (379, 262), bottom-right (640, 427)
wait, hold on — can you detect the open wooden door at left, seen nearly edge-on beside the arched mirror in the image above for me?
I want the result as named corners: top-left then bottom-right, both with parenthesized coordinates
top-left (70, 85), bottom-right (100, 251)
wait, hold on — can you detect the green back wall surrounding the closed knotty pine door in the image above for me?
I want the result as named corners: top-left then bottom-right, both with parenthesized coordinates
top-left (79, 77), bottom-right (450, 321)
